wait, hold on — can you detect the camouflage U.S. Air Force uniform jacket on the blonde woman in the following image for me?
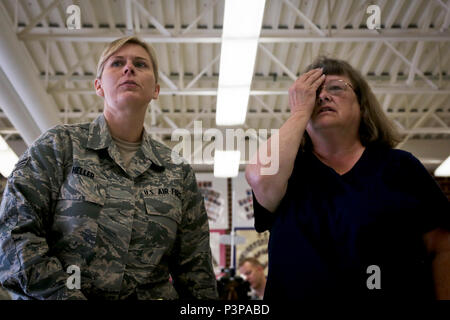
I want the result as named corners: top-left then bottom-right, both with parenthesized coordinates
top-left (0, 115), bottom-right (217, 299)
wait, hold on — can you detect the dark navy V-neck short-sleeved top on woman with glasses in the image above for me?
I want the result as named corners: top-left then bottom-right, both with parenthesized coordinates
top-left (253, 146), bottom-right (450, 300)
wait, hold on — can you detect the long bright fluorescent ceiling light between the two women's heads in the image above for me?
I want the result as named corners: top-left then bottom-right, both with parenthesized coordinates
top-left (216, 0), bottom-right (265, 126)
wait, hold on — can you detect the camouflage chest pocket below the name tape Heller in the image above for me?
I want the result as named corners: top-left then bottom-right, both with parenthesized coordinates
top-left (52, 175), bottom-right (106, 258)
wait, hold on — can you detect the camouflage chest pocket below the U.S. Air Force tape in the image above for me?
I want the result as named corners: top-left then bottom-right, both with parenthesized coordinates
top-left (144, 195), bottom-right (182, 247)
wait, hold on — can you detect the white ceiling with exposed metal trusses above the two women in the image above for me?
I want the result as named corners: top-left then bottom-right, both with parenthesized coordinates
top-left (0, 0), bottom-right (450, 174)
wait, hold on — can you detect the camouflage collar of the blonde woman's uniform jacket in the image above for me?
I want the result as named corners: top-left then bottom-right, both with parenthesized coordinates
top-left (87, 113), bottom-right (164, 167)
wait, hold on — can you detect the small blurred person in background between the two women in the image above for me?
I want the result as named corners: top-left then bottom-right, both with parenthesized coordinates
top-left (239, 258), bottom-right (266, 300)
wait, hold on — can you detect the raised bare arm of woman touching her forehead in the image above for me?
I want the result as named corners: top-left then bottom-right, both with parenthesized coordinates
top-left (245, 69), bottom-right (325, 212)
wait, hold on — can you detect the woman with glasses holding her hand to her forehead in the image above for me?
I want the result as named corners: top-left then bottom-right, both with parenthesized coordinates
top-left (246, 58), bottom-right (450, 300)
